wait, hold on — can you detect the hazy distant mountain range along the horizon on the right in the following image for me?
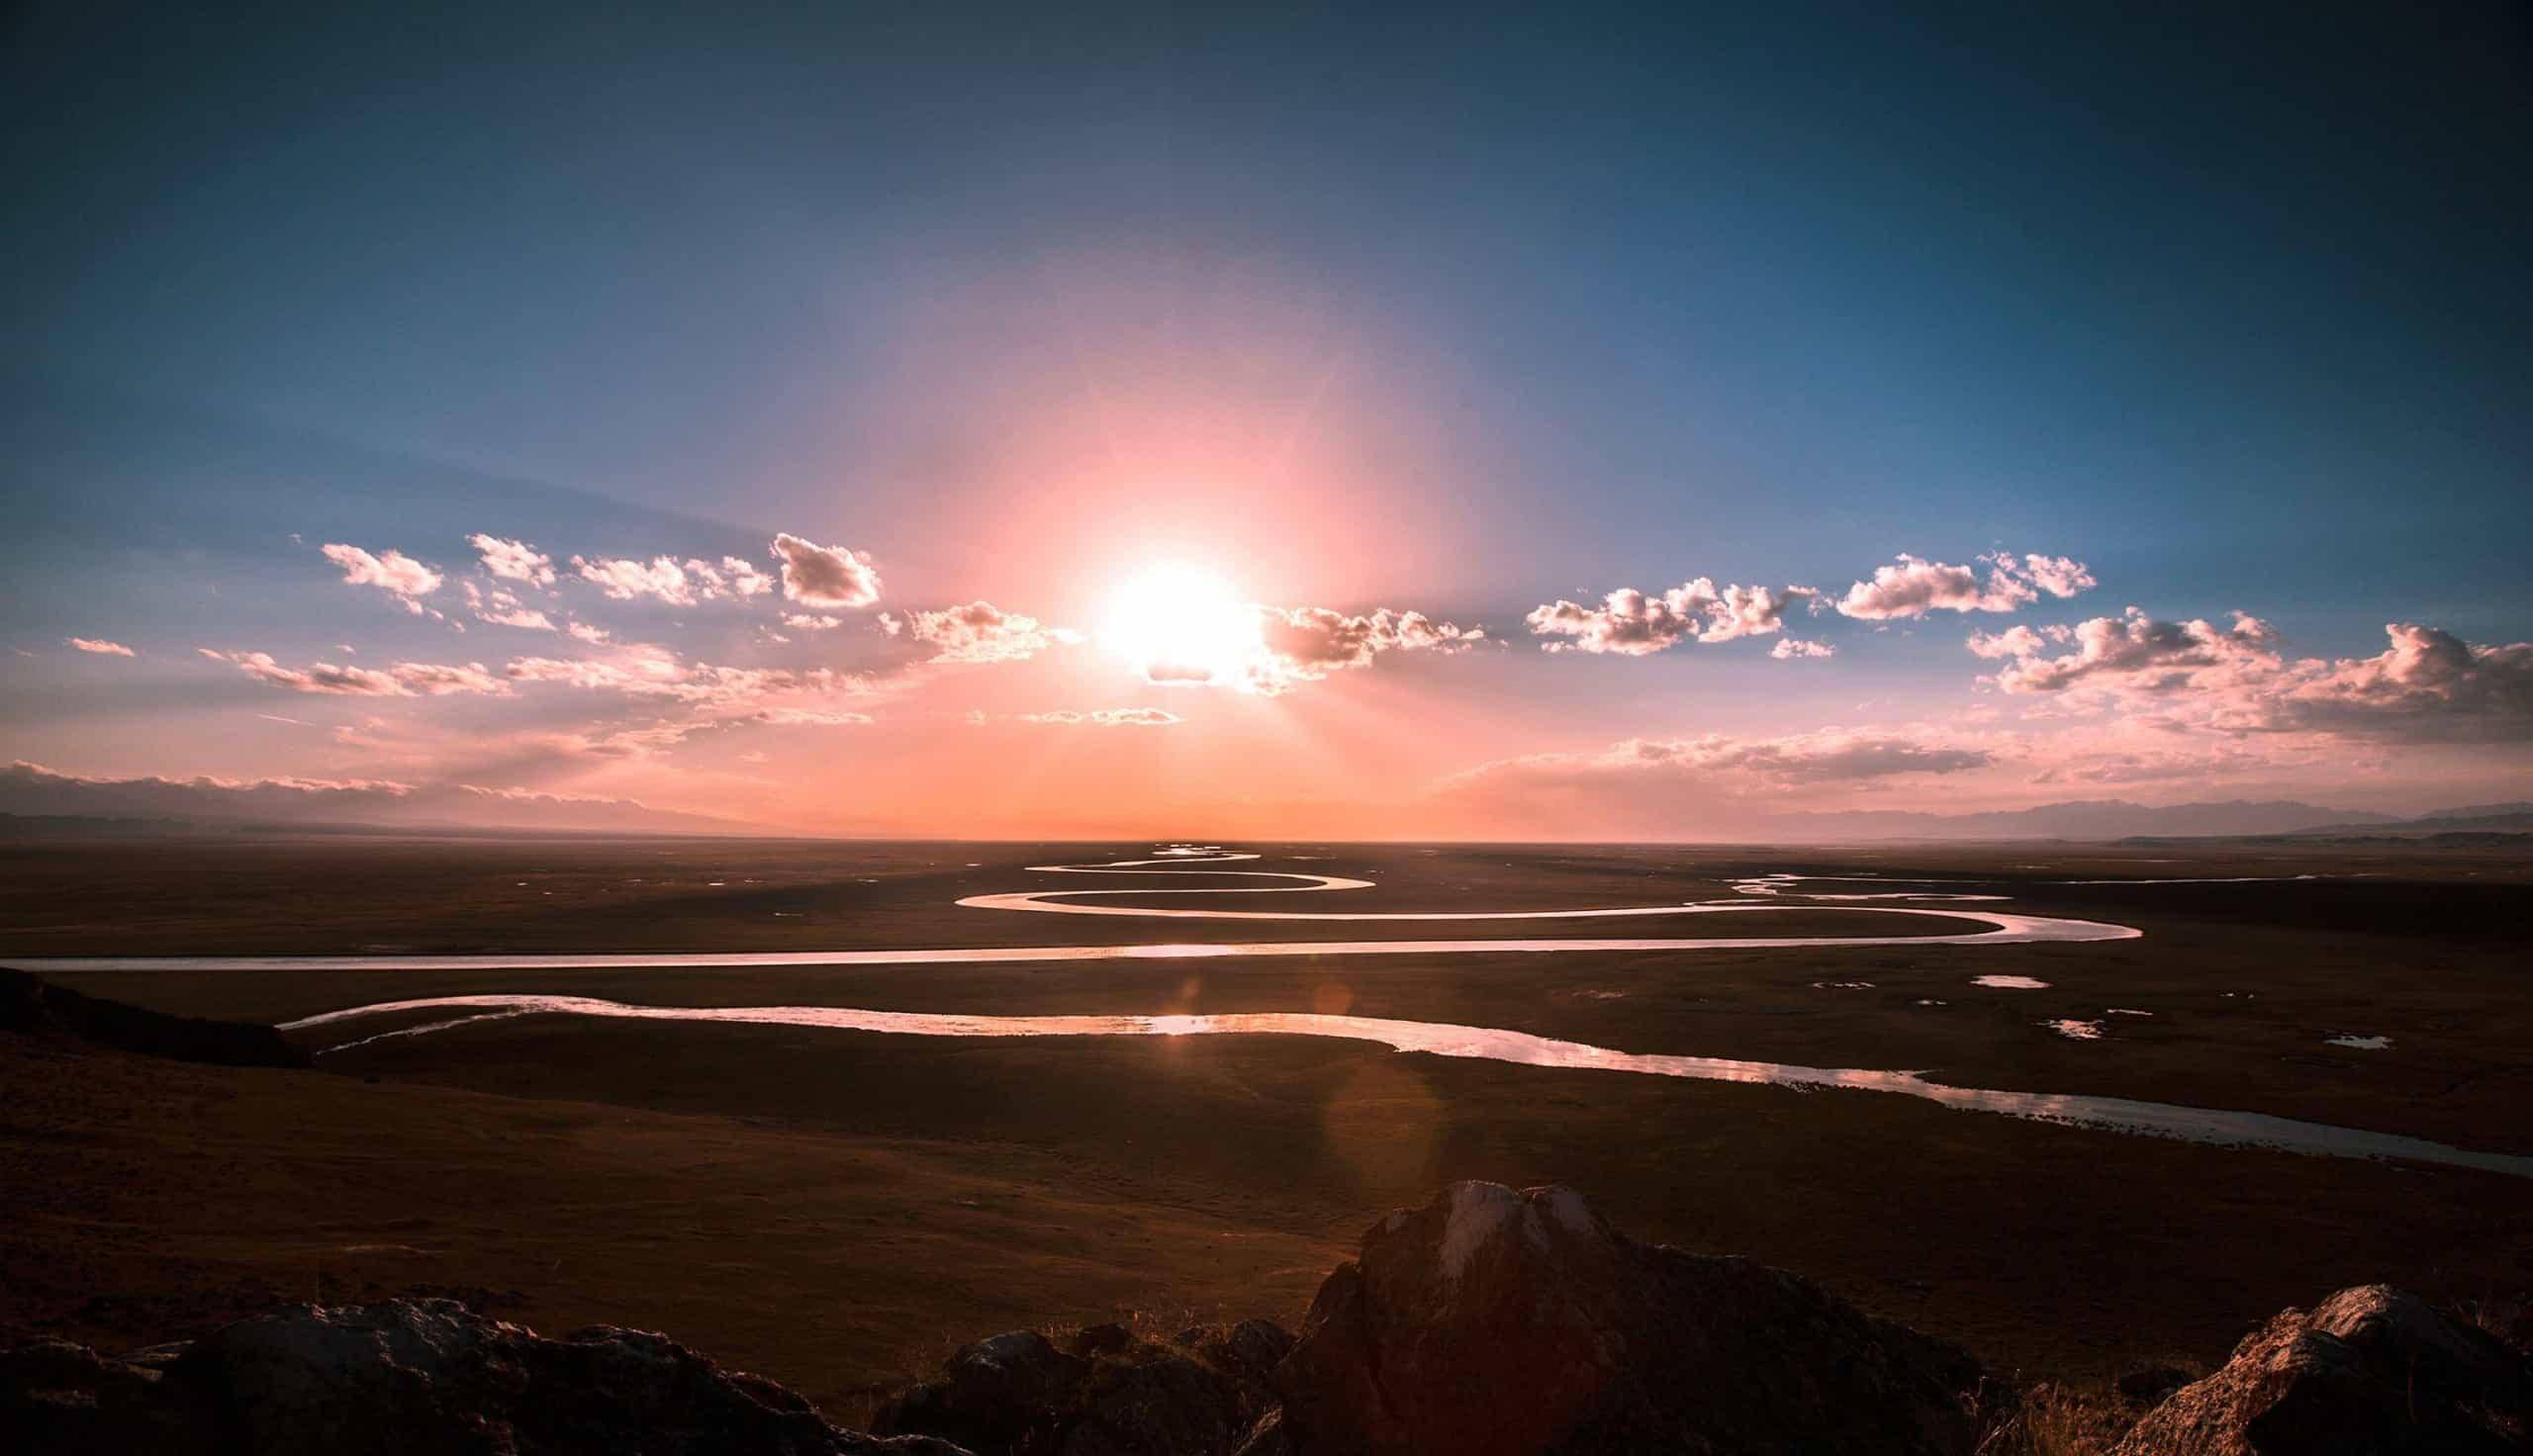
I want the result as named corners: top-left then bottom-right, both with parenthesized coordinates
top-left (1773, 797), bottom-right (2533, 841)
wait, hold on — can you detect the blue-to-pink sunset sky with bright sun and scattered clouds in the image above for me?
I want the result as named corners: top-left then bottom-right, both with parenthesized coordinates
top-left (0, 3), bottom-right (2533, 838)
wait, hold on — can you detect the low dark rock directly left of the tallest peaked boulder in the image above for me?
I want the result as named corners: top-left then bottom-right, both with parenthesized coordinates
top-left (877, 1320), bottom-right (1292, 1456)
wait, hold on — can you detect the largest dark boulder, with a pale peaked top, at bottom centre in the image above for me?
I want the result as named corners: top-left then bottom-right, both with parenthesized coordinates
top-left (1276, 1183), bottom-right (1981, 1456)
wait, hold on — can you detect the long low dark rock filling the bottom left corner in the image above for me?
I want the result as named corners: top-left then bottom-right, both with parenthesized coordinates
top-left (0, 1299), bottom-right (960, 1456)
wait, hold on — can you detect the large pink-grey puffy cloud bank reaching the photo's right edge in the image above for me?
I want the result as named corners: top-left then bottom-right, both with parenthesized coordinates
top-left (1971, 607), bottom-right (2533, 742)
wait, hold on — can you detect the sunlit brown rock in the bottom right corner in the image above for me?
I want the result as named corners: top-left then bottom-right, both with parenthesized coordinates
top-left (2115, 1284), bottom-right (2533, 1456)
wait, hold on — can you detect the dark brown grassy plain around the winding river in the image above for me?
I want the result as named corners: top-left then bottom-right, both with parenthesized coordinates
top-left (0, 838), bottom-right (2533, 1403)
